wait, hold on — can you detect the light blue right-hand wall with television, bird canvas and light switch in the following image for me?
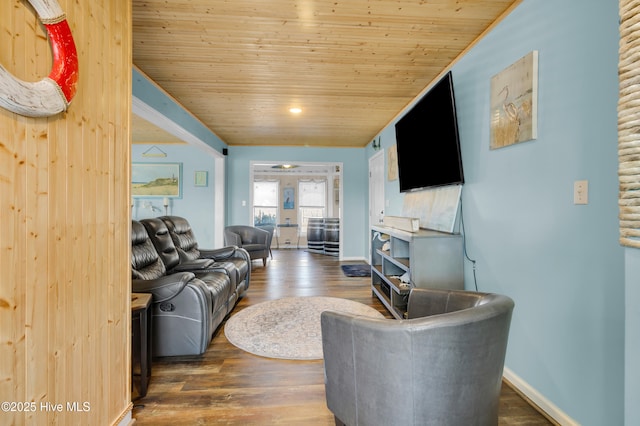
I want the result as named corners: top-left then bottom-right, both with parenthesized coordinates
top-left (368, 0), bottom-right (624, 425)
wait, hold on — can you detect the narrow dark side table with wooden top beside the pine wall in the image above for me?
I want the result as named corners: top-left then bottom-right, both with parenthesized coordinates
top-left (131, 293), bottom-right (152, 398)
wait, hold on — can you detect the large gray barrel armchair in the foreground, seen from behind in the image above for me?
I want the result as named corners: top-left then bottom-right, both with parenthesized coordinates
top-left (321, 289), bottom-right (514, 426)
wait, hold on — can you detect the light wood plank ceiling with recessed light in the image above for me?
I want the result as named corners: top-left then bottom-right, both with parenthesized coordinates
top-left (133, 0), bottom-right (520, 147)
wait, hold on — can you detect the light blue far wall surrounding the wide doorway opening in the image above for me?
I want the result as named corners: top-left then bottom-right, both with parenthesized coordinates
top-left (227, 146), bottom-right (369, 258)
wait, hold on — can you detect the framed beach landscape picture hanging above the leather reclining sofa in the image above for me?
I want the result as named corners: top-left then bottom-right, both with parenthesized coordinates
top-left (131, 163), bottom-right (182, 198)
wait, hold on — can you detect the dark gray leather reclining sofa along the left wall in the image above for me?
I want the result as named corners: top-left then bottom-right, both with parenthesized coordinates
top-left (131, 218), bottom-right (250, 357)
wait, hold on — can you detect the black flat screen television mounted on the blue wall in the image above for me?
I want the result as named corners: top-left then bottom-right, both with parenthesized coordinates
top-left (395, 71), bottom-right (464, 192)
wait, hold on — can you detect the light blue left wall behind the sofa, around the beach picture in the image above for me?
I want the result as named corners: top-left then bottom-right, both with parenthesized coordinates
top-left (131, 144), bottom-right (220, 248)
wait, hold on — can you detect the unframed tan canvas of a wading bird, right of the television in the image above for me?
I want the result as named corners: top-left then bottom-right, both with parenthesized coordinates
top-left (490, 50), bottom-right (538, 149)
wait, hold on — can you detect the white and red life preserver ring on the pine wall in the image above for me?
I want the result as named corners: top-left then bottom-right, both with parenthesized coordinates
top-left (0, 0), bottom-right (78, 117)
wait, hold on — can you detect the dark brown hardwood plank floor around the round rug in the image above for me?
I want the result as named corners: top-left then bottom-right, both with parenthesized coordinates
top-left (133, 249), bottom-right (552, 426)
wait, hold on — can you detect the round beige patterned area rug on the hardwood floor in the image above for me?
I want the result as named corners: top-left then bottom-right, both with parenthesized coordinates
top-left (224, 297), bottom-right (384, 360)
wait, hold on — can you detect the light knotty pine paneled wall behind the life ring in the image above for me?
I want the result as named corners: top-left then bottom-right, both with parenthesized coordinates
top-left (0, 0), bottom-right (132, 425)
